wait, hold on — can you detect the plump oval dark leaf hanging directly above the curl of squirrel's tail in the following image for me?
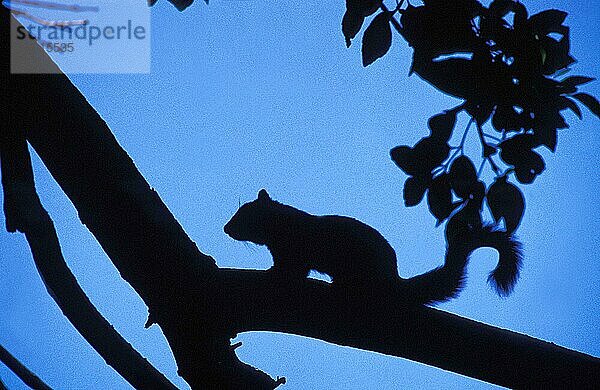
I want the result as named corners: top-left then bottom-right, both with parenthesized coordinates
top-left (487, 176), bottom-right (525, 233)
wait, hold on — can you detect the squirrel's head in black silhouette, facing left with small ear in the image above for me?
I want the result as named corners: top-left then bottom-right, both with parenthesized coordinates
top-left (223, 189), bottom-right (274, 245)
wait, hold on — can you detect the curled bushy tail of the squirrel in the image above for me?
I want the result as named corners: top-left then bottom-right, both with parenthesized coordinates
top-left (403, 225), bottom-right (523, 304)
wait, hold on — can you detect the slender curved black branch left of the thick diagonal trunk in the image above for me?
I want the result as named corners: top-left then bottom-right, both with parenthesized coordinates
top-left (0, 127), bottom-right (176, 389)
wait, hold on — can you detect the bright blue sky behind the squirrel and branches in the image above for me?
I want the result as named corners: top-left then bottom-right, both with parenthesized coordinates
top-left (0, 0), bottom-right (600, 390)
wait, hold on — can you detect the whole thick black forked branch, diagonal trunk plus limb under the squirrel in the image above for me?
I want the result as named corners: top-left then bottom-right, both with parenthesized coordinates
top-left (2, 5), bottom-right (600, 388)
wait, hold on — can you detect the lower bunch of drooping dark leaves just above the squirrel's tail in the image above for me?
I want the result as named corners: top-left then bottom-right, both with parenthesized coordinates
top-left (391, 111), bottom-right (524, 233)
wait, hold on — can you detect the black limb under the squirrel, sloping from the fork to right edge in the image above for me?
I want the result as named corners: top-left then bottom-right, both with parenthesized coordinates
top-left (214, 269), bottom-right (600, 389)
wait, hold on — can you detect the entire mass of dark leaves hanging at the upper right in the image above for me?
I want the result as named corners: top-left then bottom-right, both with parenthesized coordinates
top-left (342, 0), bottom-right (600, 232)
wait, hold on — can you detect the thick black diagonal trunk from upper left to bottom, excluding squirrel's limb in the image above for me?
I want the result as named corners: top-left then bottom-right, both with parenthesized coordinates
top-left (0, 7), bottom-right (280, 388)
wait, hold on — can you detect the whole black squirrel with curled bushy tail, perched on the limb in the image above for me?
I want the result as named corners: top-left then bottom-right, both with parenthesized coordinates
top-left (224, 189), bottom-right (522, 304)
